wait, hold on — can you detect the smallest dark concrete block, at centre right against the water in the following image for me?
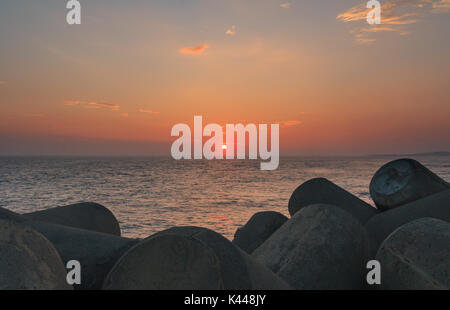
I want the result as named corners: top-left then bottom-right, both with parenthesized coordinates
top-left (232, 211), bottom-right (288, 254)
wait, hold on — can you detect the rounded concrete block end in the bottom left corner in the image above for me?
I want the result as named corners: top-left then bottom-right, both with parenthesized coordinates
top-left (0, 219), bottom-right (72, 290)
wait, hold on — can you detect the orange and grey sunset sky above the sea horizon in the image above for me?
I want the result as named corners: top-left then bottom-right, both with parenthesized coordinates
top-left (0, 0), bottom-right (450, 156)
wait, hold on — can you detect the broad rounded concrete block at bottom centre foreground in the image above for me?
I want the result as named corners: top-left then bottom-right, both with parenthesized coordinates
top-left (104, 227), bottom-right (290, 289)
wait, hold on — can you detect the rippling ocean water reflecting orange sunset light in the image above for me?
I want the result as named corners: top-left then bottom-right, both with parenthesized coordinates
top-left (0, 156), bottom-right (450, 239)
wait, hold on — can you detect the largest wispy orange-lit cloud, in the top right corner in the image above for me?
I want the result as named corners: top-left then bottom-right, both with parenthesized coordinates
top-left (336, 0), bottom-right (450, 44)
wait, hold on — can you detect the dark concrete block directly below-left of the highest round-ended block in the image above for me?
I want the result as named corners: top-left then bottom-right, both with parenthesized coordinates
top-left (289, 178), bottom-right (378, 224)
